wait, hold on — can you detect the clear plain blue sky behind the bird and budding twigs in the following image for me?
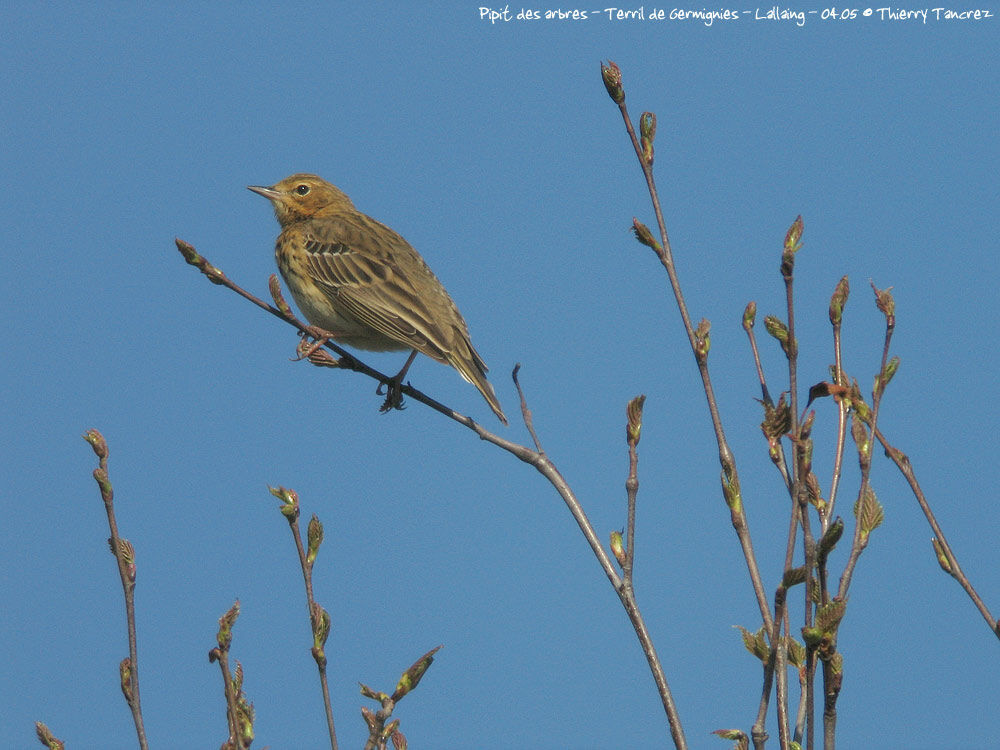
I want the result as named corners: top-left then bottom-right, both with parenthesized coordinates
top-left (0, 3), bottom-right (1000, 748)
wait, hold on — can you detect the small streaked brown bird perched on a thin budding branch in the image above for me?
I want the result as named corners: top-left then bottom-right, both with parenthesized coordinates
top-left (248, 173), bottom-right (507, 424)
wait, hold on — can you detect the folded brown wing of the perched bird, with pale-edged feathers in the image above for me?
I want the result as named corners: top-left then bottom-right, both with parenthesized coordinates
top-left (305, 225), bottom-right (460, 362)
